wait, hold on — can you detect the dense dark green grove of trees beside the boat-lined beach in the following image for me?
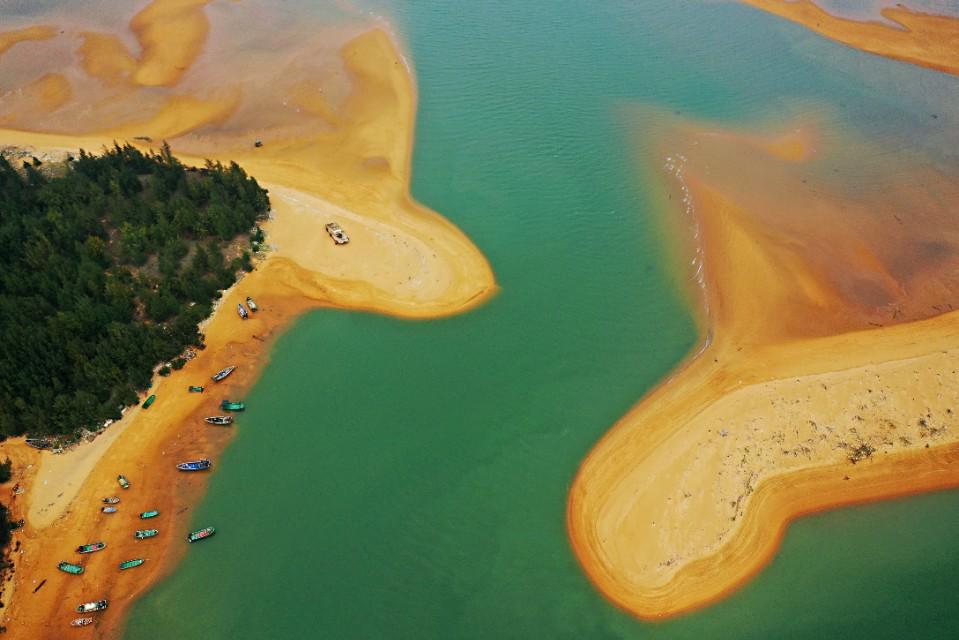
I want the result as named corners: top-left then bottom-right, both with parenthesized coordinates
top-left (0, 144), bottom-right (269, 438)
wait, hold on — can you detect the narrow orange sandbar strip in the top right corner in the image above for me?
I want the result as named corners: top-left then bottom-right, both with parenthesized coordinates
top-left (742, 0), bottom-right (959, 74)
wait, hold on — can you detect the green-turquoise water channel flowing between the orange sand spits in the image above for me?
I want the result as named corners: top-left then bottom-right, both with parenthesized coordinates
top-left (125, 0), bottom-right (959, 640)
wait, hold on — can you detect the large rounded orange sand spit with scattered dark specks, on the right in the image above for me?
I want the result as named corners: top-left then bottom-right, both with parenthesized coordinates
top-left (567, 117), bottom-right (959, 619)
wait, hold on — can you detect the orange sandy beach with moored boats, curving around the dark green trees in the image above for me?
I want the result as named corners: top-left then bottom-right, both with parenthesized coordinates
top-left (0, 11), bottom-right (496, 640)
